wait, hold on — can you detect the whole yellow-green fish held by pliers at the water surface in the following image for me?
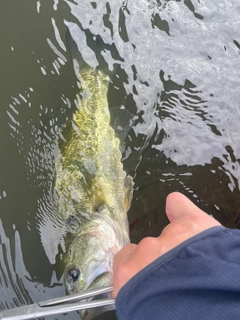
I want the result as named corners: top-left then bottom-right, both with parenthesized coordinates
top-left (54, 28), bottom-right (134, 319)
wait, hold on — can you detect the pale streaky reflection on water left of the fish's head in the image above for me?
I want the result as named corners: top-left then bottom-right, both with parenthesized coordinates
top-left (0, 220), bottom-right (64, 319)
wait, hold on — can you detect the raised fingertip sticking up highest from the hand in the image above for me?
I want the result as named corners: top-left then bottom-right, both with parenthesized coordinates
top-left (166, 192), bottom-right (203, 222)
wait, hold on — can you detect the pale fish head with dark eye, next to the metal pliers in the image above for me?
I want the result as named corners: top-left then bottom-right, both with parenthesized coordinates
top-left (64, 206), bottom-right (129, 319)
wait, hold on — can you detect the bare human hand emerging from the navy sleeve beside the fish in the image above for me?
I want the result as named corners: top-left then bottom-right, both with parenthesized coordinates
top-left (112, 192), bottom-right (221, 297)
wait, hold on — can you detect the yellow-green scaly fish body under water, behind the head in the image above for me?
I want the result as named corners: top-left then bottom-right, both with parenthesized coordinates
top-left (55, 69), bottom-right (131, 222)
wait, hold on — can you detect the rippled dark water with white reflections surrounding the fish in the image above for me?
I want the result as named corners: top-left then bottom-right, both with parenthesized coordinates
top-left (0, 0), bottom-right (240, 319)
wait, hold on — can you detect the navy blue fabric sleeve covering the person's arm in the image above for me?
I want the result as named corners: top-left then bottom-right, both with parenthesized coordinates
top-left (116, 227), bottom-right (240, 320)
